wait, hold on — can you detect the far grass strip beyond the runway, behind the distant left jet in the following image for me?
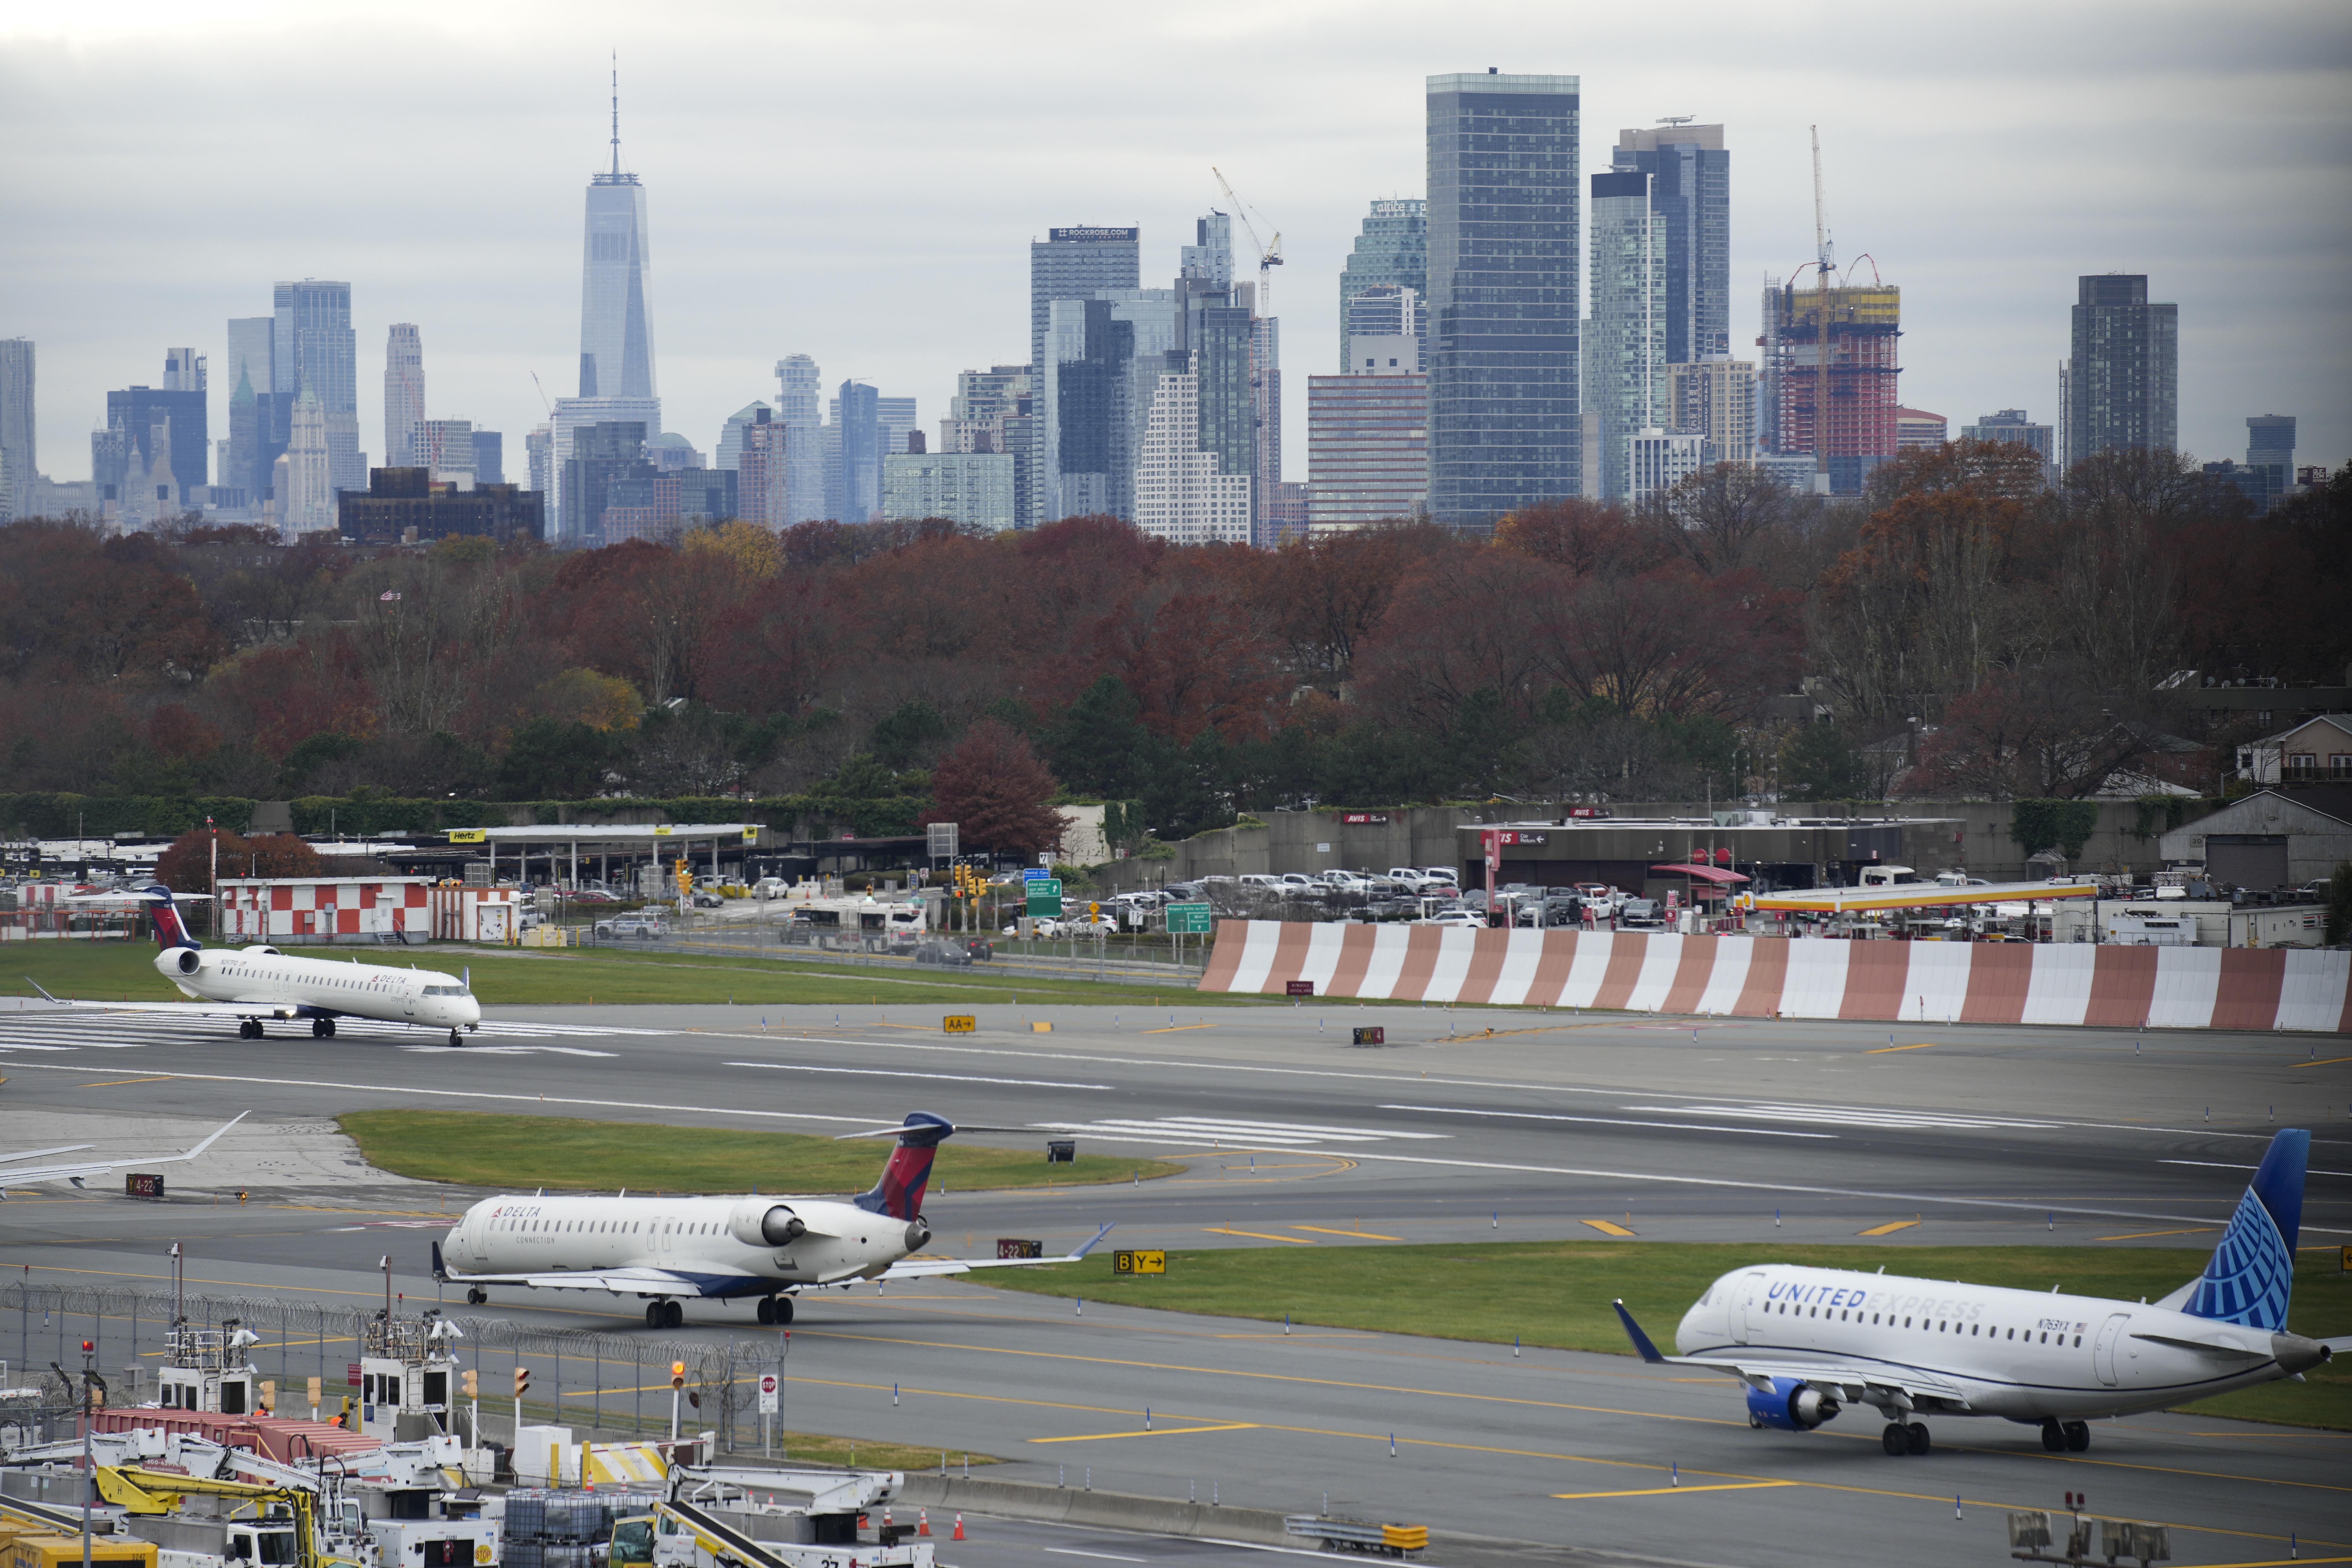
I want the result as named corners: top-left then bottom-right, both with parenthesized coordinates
top-left (0, 943), bottom-right (1261, 1009)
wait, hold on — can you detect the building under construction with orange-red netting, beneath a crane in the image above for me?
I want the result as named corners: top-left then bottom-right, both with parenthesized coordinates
top-left (1757, 278), bottom-right (1903, 496)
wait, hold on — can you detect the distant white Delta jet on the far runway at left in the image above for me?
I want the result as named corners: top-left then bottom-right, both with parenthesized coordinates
top-left (31, 882), bottom-right (482, 1046)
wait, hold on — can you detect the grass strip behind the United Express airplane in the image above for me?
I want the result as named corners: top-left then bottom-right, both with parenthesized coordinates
top-left (986, 1241), bottom-right (2352, 1429)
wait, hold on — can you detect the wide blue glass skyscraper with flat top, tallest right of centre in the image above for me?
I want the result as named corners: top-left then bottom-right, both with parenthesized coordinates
top-left (1428, 68), bottom-right (1583, 529)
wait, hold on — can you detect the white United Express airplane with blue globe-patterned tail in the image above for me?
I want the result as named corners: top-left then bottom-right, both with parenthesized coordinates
top-left (1616, 1128), bottom-right (2352, 1455)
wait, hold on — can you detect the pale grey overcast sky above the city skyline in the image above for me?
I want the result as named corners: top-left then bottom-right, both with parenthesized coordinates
top-left (0, 0), bottom-right (2352, 491)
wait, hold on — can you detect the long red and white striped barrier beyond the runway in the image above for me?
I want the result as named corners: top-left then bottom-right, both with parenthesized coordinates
top-left (1200, 919), bottom-right (2352, 1032)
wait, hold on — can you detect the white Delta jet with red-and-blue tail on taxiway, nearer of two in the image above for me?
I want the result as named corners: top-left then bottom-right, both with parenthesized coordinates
top-left (433, 1110), bottom-right (1110, 1328)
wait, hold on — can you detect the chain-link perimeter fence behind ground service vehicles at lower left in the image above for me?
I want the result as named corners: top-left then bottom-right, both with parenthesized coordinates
top-left (0, 1284), bottom-right (790, 1453)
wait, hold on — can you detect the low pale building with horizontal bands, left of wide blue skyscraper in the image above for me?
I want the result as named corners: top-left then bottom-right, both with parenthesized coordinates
top-left (1308, 362), bottom-right (1430, 534)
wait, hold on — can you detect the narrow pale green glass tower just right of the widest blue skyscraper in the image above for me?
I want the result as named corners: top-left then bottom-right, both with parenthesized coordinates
top-left (1583, 169), bottom-right (1668, 501)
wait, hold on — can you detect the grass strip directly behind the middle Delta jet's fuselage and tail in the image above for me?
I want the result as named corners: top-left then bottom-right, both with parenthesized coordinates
top-left (336, 1110), bottom-right (1181, 1192)
